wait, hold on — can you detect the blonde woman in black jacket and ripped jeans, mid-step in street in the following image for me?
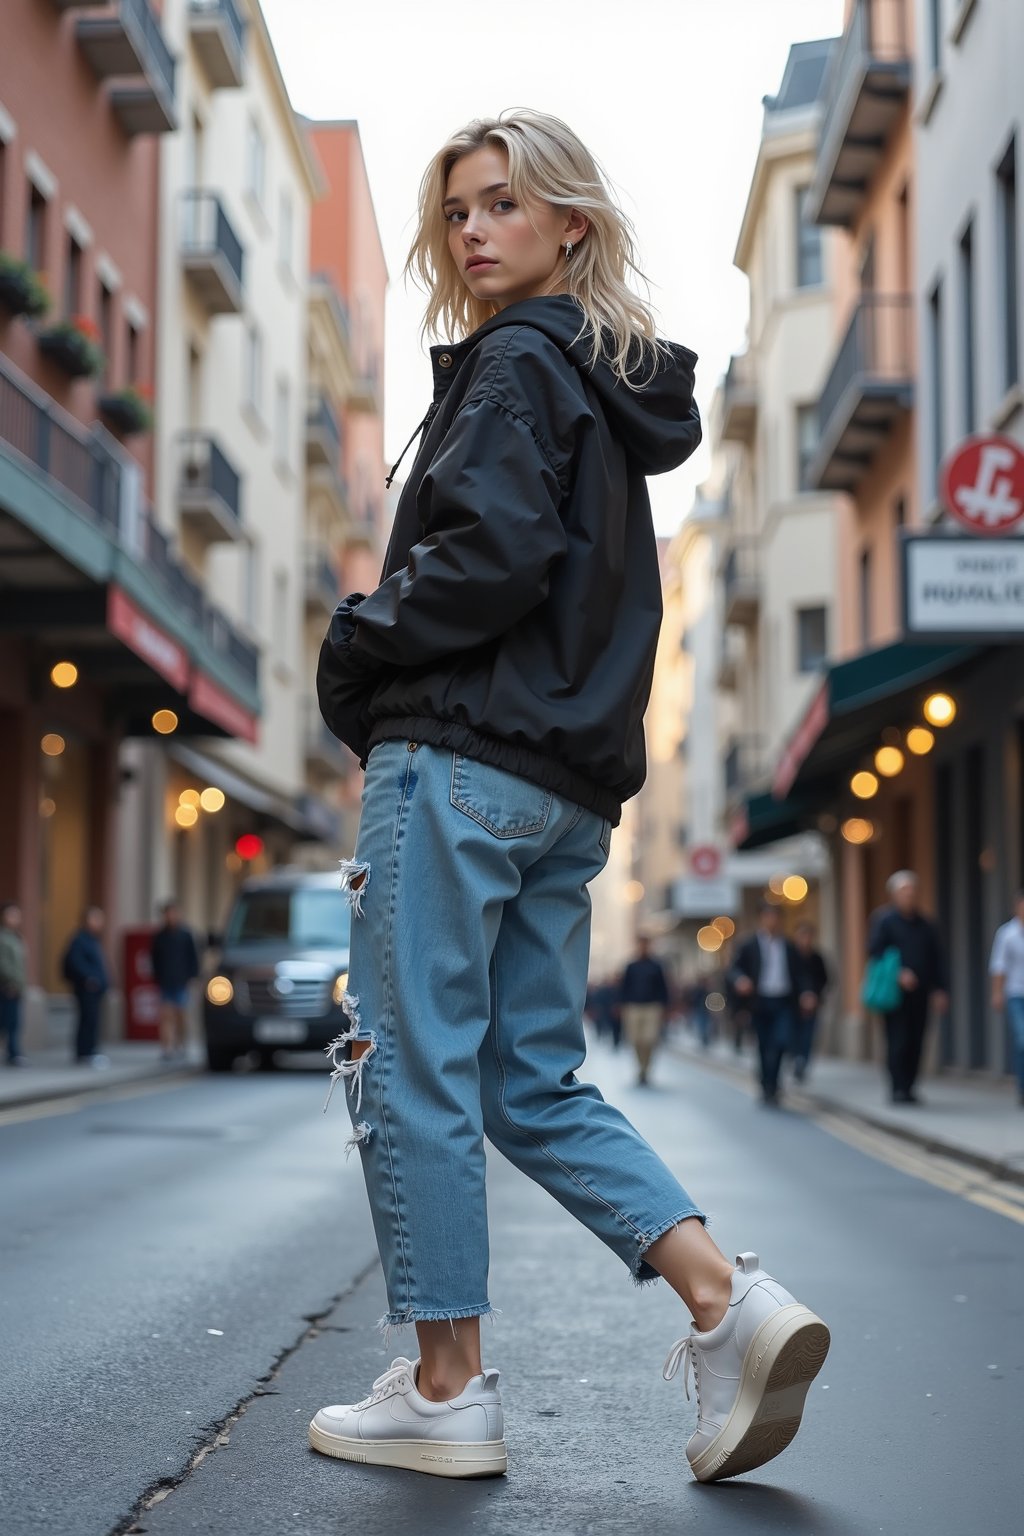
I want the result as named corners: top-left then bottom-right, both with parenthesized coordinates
top-left (310, 112), bottom-right (829, 1479)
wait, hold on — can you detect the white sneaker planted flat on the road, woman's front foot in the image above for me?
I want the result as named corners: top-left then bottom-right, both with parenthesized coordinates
top-left (309, 1356), bottom-right (508, 1478)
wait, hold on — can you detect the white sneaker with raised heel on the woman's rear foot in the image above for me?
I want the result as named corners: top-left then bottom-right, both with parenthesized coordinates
top-left (663, 1253), bottom-right (831, 1482)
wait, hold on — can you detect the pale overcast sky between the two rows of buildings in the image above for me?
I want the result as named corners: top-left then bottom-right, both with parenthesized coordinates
top-left (263, 0), bottom-right (843, 533)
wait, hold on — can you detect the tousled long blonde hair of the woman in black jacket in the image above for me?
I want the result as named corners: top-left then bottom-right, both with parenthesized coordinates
top-left (405, 111), bottom-right (660, 386)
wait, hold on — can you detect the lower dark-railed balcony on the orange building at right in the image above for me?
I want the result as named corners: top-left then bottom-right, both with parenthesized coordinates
top-left (808, 293), bottom-right (913, 495)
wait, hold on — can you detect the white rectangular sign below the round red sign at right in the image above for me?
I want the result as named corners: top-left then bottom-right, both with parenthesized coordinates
top-left (903, 535), bottom-right (1024, 641)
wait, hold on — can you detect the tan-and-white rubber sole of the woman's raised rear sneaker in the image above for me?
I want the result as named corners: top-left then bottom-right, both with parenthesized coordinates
top-left (689, 1304), bottom-right (831, 1482)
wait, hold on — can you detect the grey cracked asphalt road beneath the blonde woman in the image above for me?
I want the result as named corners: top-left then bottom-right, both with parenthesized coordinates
top-left (0, 1051), bottom-right (1024, 1536)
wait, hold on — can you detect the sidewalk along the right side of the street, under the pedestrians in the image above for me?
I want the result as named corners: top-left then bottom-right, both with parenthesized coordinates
top-left (669, 1031), bottom-right (1024, 1184)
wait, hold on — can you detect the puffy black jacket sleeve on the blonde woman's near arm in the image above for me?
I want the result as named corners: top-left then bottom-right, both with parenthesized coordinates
top-left (342, 398), bottom-right (567, 666)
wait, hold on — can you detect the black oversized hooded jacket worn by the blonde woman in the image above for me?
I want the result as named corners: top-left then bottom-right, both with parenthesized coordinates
top-left (316, 295), bottom-right (700, 823)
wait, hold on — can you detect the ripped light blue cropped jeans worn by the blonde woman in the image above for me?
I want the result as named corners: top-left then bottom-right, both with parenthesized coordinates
top-left (329, 742), bottom-right (703, 1326)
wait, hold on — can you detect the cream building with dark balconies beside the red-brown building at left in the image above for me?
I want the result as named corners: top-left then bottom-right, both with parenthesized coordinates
top-left (120, 0), bottom-right (335, 926)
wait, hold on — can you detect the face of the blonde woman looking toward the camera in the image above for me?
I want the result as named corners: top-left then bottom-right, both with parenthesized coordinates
top-left (444, 144), bottom-right (586, 309)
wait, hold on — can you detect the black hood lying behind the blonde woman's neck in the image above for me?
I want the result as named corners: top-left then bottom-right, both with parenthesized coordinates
top-left (462, 293), bottom-right (700, 475)
